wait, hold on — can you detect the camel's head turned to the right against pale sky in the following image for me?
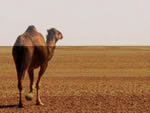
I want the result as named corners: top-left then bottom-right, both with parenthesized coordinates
top-left (47, 28), bottom-right (63, 42)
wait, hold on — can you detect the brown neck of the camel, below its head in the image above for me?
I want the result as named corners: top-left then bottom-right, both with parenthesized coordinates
top-left (47, 39), bottom-right (56, 60)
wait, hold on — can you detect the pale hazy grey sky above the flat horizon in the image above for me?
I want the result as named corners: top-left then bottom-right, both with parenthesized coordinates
top-left (0, 0), bottom-right (150, 46)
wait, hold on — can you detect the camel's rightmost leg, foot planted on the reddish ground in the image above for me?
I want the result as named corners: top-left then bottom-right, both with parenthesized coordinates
top-left (36, 64), bottom-right (47, 105)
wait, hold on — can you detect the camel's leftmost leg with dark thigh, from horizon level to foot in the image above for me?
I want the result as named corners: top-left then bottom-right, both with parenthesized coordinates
top-left (12, 46), bottom-right (33, 107)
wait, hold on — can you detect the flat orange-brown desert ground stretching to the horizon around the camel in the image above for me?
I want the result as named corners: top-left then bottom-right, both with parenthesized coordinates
top-left (0, 46), bottom-right (150, 113)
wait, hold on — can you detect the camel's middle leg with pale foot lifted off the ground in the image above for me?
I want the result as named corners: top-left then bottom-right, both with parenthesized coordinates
top-left (26, 69), bottom-right (34, 101)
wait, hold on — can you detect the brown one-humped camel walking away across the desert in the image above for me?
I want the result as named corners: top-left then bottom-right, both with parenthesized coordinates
top-left (12, 25), bottom-right (63, 107)
